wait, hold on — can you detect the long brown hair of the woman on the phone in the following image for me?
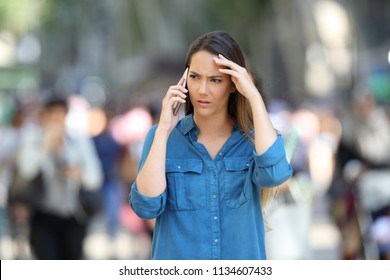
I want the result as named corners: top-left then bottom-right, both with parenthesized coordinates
top-left (185, 31), bottom-right (277, 229)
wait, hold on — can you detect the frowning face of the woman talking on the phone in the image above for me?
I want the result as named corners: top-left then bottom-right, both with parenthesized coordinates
top-left (187, 51), bottom-right (235, 116)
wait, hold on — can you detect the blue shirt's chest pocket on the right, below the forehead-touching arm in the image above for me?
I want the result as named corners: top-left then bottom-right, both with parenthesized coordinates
top-left (224, 157), bottom-right (252, 208)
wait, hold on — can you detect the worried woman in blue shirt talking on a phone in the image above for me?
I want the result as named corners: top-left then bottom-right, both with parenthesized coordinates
top-left (129, 31), bottom-right (292, 259)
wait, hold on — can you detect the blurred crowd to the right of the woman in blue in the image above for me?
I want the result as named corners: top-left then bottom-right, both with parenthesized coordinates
top-left (268, 77), bottom-right (390, 259)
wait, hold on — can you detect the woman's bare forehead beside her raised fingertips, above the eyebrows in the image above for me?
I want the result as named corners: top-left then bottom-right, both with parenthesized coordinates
top-left (189, 51), bottom-right (222, 75)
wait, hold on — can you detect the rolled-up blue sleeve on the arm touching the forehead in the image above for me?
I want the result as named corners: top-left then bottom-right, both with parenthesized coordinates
top-left (252, 134), bottom-right (293, 188)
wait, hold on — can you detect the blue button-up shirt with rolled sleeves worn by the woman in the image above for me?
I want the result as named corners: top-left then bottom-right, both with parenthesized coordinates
top-left (129, 115), bottom-right (292, 260)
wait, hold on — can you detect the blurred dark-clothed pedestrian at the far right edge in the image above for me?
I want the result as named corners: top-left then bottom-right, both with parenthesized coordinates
top-left (330, 87), bottom-right (390, 259)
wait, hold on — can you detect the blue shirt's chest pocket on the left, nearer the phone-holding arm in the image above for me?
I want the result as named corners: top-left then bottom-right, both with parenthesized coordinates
top-left (166, 159), bottom-right (206, 211)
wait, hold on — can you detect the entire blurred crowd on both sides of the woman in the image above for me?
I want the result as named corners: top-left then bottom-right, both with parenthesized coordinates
top-left (0, 69), bottom-right (390, 259)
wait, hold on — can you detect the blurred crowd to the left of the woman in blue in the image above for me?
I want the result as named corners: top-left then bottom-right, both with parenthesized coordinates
top-left (0, 95), bottom-right (153, 259)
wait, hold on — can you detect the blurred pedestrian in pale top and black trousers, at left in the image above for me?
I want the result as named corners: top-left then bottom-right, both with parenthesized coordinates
top-left (18, 98), bottom-right (102, 259)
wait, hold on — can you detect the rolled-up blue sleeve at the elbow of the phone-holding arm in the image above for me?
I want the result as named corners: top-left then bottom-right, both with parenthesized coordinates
top-left (129, 182), bottom-right (167, 219)
